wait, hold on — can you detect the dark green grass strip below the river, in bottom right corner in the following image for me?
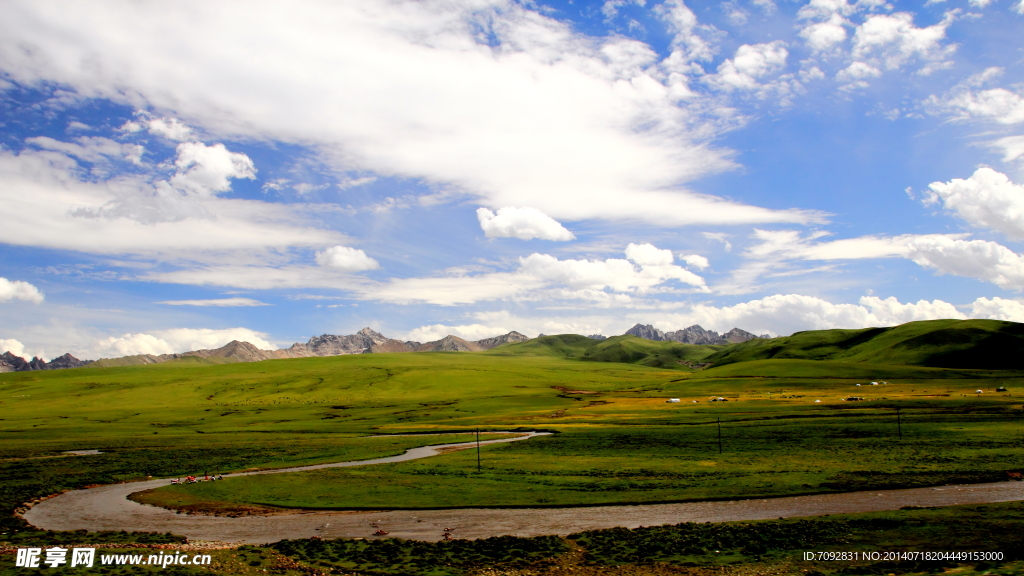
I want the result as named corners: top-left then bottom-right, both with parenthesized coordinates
top-left (568, 502), bottom-right (1024, 575)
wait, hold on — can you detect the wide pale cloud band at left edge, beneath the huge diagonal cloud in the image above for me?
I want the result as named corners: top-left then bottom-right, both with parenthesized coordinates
top-left (0, 145), bottom-right (345, 261)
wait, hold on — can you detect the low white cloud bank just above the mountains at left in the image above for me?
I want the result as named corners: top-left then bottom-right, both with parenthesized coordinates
top-left (91, 328), bottom-right (276, 358)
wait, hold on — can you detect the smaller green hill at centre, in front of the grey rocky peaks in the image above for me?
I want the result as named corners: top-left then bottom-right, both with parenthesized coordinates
top-left (487, 334), bottom-right (725, 369)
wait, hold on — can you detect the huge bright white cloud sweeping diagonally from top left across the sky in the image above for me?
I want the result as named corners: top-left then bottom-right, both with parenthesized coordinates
top-left (0, 0), bottom-right (823, 227)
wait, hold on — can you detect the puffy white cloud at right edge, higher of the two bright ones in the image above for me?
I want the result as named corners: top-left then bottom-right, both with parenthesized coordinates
top-left (927, 167), bottom-right (1024, 240)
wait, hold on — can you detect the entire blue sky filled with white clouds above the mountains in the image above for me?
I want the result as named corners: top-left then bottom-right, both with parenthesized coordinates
top-left (0, 0), bottom-right (1024, 359)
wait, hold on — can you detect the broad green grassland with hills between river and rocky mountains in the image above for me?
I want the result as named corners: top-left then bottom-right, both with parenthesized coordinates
top-left (0, 321), bottom-right (1024, 530)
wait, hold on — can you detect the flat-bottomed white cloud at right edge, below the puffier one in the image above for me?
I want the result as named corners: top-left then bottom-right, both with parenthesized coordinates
top-left (906, 237), bottom-right (1024, 290)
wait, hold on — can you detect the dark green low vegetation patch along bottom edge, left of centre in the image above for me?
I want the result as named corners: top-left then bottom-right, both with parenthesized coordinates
top-left (268, 536), bottom-right (569, 576)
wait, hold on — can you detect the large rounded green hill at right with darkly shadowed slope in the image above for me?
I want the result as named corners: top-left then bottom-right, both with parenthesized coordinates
top-left (708, 320), bottom-right (1024, 369)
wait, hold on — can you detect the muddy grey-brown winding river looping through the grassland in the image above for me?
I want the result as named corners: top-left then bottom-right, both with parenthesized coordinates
top-left (24, 433), bottom-right (1024, 544)
